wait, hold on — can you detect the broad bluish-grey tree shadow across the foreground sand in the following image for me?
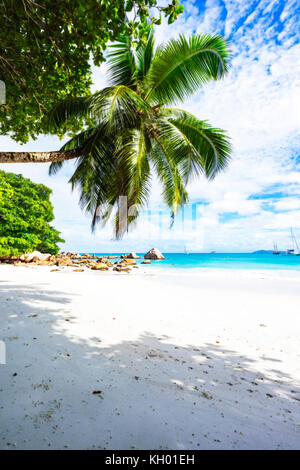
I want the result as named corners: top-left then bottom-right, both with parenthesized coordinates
top-left (0, 282), bottom-right (300, 449)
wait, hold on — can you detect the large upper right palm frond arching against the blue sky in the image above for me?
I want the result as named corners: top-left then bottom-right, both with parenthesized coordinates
top-left (146, 34), bottom-right (229, 104)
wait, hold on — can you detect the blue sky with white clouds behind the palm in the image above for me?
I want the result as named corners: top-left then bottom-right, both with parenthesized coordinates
top-left (0, 0), bottom-right (300, 252)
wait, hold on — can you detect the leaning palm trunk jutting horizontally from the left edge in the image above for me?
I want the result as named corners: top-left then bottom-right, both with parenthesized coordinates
top-left (0, 149), bottom-right (80, 163)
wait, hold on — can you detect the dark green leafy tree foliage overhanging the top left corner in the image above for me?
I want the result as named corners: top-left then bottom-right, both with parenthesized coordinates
top-left (0, 0), bottom-right (183, 143)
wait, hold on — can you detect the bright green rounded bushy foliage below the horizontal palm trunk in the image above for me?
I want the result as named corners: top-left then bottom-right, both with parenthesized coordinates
top-left (0, 170), bottom-right (64, 256)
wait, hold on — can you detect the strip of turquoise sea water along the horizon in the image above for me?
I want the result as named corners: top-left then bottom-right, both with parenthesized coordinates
top-left (93, 253), bottom-right (300, 271)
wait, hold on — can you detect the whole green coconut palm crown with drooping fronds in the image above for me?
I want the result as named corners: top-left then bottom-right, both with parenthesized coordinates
top-left (45, 33), bottom-right (231, 238)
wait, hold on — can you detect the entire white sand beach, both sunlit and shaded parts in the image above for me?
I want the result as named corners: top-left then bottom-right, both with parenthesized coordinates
top-left (0, 265), bottom-right (300, 449)
